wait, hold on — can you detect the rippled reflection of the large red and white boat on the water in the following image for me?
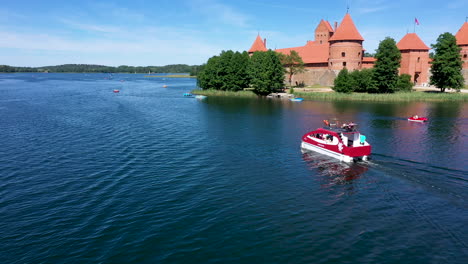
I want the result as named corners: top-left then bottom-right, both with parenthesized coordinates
top-left (302, 151), bottom-right (368, 194)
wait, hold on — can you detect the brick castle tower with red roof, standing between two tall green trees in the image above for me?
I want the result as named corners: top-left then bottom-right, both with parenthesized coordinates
top-left (397, 33), bottom-right (429, 84)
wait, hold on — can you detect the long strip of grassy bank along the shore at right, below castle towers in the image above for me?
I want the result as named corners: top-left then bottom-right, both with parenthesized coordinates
top-left (294, 92), bottom-right (468, 102)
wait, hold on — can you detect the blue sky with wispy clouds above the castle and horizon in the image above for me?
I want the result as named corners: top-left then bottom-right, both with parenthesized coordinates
top-left (0, 0), bottom-right (468, 67)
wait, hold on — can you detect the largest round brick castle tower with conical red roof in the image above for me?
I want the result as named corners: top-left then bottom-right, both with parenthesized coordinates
top-left (328, 14), bottom-right (364, 71)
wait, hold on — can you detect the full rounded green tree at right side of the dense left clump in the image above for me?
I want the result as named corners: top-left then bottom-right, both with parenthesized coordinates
top-left (248, 50), bottom-right (284, 96)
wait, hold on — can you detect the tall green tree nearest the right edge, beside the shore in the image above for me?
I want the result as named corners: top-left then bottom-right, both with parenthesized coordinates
top-left (430, 32), bottom-right (464, 92)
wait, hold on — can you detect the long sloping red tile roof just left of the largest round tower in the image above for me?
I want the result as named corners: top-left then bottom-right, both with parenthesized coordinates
top-left (275, 41), bottom-right (330, 63)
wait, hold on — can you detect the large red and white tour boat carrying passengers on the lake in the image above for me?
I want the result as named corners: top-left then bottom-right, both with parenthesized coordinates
top-left (301, 120), bottom-right (372, 162)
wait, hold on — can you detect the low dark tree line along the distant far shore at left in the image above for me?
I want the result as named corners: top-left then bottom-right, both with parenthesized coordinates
top-left (0, 64), bottom-right (200, 75)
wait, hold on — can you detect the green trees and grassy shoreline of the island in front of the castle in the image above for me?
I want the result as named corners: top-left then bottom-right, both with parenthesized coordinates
top-left (193, 33), bottom-right (468, 101)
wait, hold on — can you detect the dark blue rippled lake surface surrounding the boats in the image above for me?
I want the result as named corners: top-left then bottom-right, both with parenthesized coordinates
top-left (0, 73), bottom-right (468, 263)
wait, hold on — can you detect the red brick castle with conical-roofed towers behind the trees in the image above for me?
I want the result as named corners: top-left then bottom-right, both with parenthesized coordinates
top-left (248, 14), bottom-right (468, 85)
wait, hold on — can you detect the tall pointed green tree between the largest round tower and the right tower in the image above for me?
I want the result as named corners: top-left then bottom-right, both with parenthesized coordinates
top-left (370, 37), bottom-right (401, 93)
